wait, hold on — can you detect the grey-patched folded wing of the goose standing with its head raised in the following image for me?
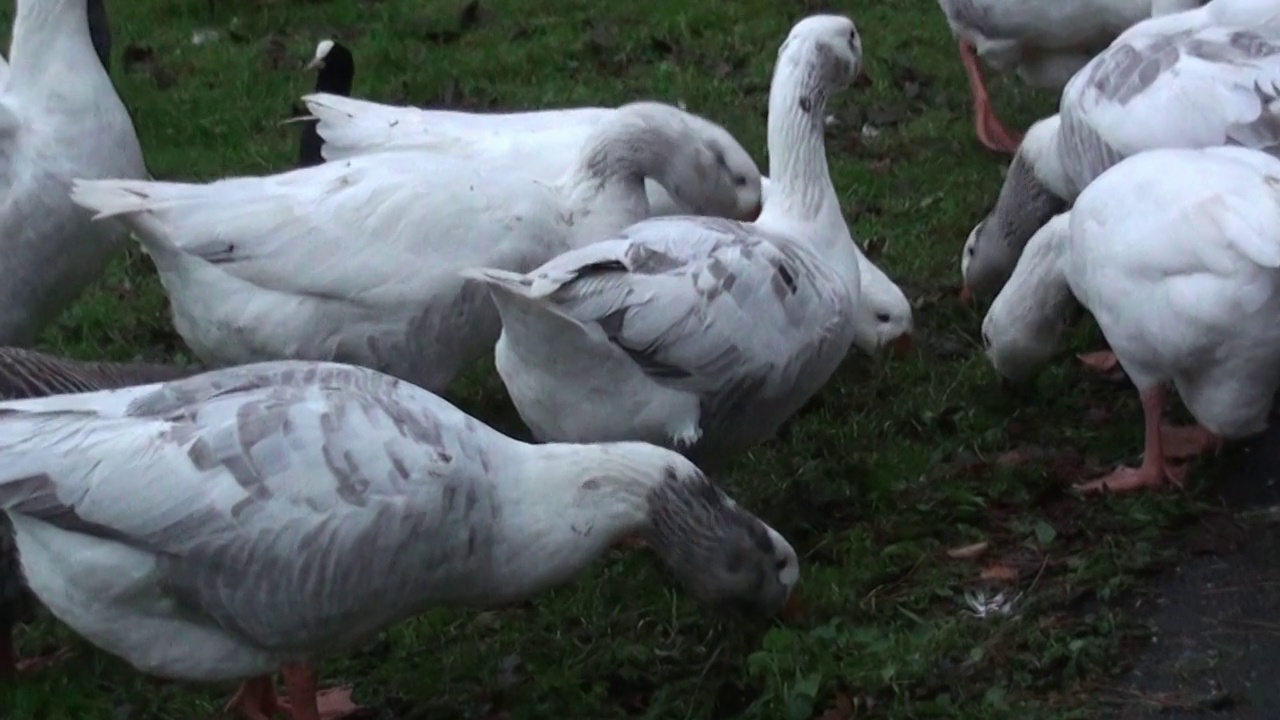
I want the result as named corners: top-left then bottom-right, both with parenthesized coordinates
top-left (519, 218), bottom-right (844, 422)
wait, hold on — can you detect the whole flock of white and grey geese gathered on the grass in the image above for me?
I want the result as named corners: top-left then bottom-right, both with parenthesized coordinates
top-left (0, 0), bottom-right (1280, 720)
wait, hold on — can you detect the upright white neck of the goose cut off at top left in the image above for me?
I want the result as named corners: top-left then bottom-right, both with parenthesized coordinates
top-left (9, 0), bottom-right (106, 96)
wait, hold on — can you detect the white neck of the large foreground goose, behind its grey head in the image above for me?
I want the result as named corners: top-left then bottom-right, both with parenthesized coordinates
top-left (454, 442), bottom-right (687, 602)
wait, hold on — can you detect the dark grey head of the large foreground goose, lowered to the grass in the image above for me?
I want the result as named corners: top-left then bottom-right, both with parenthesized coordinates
top-left (643, 454), bottom-right (800, 615)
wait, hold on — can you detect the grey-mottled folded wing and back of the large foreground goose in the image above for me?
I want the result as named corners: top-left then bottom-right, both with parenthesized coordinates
top-left (0, 363), bottom-right (500, 652)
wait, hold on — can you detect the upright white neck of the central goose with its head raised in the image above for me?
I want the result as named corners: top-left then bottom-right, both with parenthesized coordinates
top-left (764, 45), bottom-right (840, 222)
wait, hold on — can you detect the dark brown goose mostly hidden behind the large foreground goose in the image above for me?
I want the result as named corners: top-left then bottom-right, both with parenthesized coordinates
top-left (0, 347), bottom-right (196, 679)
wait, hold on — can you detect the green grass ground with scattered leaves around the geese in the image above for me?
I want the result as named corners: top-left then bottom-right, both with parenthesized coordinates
top-left (0, 0), bottom-right (1204, 720)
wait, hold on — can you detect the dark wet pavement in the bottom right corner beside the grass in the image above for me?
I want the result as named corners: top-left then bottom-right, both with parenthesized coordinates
top-left (1106, 425), bottom-right (1280, 720)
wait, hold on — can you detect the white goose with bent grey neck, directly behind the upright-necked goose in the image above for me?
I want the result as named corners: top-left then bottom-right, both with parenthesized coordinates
top-left (72, 102), bottom-right (757, 392)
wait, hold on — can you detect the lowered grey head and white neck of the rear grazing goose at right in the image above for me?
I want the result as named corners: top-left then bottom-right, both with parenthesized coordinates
top-left (960, 115), bottom-right (1068, 300)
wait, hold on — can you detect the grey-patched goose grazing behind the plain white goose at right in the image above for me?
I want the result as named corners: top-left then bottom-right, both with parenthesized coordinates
top-left (960, 0), bottom-right (1280, 363)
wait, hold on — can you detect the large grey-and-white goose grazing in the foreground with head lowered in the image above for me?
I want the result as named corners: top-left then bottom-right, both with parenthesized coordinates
top-left (0, 360), bottom-right (800, 720)
